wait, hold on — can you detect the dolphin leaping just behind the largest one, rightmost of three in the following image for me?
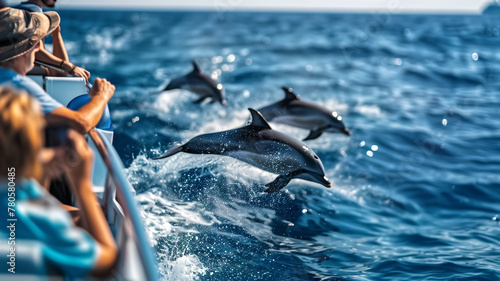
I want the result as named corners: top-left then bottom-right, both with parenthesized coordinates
top-left (259, 87), bottom-right (351, 141)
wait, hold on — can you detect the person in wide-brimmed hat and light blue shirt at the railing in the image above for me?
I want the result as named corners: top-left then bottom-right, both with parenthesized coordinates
top-left (0, 8), bottom-right (115, 133)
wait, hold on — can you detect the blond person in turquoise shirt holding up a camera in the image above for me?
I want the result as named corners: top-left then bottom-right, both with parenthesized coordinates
top-left (0, 87), bottom-right (117, 278)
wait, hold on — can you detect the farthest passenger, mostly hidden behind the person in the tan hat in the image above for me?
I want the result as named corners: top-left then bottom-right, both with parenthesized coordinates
top-left (14, 0), bottom-right (90, 83)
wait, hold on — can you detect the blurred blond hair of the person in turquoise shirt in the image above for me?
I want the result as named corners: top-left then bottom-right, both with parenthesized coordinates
top-left (0, 87), bottom-right (44, 179)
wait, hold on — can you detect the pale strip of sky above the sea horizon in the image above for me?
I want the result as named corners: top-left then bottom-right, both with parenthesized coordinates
top-left (5, 0), bottom-right (500, 13)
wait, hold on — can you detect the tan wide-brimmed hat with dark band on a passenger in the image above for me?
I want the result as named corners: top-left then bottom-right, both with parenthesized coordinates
top-left (0, 8), bottom-right (61, 62)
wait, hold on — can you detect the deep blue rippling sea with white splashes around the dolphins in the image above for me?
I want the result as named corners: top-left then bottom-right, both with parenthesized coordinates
top-left (55, 8), bottom-right (500, 281)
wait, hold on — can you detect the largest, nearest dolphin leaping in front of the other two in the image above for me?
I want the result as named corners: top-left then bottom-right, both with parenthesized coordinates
top-left (155, 108), bottom-right (332, 193)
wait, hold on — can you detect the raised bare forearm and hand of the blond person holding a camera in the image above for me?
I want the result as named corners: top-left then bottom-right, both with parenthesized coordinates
top-left (62, 130), bottom-right (118, 276)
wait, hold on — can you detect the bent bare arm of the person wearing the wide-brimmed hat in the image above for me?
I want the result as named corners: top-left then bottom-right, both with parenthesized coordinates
top-left (45, 78), bottom-right (115, 134)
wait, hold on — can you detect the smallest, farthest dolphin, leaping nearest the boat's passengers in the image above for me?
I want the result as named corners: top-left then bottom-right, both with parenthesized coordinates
top-left (163, 61), bottom-right (226, 106)
